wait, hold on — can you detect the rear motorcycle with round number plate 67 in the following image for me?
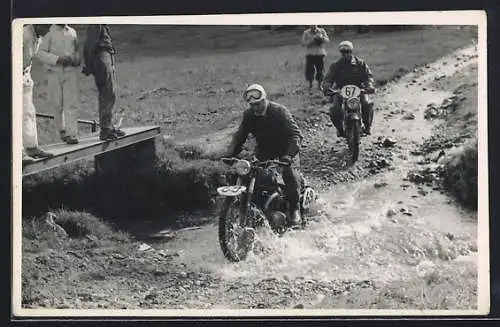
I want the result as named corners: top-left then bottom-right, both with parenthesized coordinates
top-left (327, 84), bottom-right (367, 163)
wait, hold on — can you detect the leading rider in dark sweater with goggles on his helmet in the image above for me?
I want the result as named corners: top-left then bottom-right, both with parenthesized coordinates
top-left (228, 84), bottom-right (303, 225)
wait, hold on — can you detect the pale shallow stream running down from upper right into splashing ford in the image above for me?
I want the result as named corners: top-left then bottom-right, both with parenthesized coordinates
top-left (159, 44), bottom-right (477, 288)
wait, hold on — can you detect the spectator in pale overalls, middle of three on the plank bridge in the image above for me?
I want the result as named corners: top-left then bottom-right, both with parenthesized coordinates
top-left (39, 24), bottom-right (81, 144)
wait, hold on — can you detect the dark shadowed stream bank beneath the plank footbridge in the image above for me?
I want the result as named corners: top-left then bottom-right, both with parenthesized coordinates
top-left (22, 138), bottom-right (225, 220)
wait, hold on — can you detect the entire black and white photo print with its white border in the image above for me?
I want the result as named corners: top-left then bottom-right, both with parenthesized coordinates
top-left (12, 11), bottom-right (490, 317)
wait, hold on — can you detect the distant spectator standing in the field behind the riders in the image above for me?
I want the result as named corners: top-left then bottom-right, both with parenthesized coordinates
top-left (302, 25), bottom-right (330, 90)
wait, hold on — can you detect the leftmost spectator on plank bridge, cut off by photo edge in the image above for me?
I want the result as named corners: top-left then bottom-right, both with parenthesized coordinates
top-left (23, 24), bottom-right (55, 164)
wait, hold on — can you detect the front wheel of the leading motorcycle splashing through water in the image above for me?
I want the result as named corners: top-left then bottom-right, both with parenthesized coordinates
top-left (219, 197), bottom-right (254, 262)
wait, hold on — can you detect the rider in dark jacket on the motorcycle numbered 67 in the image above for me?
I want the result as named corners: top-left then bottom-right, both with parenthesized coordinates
top-left (323, 41), bottom-right (375, 137)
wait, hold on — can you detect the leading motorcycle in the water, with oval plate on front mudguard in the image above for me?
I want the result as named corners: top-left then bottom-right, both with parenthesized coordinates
top-left (217, 158), bottom-right (317, 262)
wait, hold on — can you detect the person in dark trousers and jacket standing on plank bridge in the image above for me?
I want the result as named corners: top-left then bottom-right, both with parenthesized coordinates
top-left (82, 25), bottom-right (125, 141)
